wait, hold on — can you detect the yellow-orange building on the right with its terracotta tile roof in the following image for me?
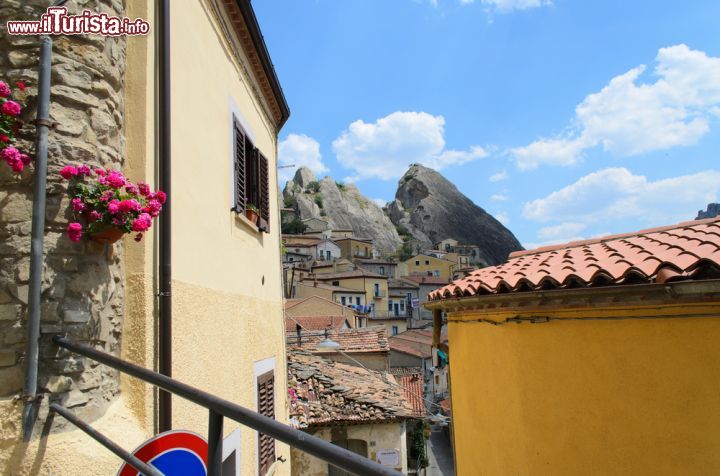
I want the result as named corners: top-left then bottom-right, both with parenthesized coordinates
top-left (427, 218), bottom-right (720, 475)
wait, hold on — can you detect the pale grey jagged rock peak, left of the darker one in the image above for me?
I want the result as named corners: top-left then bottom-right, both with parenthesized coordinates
top-left (283, 167), bottom-right (402, 255)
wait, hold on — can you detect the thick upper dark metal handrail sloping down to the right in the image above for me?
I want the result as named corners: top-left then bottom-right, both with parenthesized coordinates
top-left (53, 336), bottom-right (400, 476)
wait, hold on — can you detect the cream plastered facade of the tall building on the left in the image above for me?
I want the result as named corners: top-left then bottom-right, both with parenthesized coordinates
top-left (0, 0), bottom-right (290, 475)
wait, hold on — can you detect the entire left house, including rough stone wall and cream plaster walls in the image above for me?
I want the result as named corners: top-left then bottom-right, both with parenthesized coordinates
top-left (0, 0), bottom-right (290, 475)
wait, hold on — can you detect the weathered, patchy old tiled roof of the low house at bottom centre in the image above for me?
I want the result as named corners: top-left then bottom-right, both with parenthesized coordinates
top-left (288, 352), bottom-right (415, 428)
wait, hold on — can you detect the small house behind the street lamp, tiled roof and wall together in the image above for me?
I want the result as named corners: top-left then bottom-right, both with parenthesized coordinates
top-left (286, 326), bottom-right (390, 372)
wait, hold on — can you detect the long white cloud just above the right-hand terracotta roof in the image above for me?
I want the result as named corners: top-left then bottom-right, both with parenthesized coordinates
top-left (523, 167), bottom-right (720, 226)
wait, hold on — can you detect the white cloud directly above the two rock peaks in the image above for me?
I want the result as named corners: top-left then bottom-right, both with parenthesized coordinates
top-left (333, 111), bottom-right (488, 181)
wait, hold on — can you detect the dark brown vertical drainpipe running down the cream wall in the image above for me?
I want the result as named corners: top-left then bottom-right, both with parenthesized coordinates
top-left (157, 0), bottom-right (172, 432)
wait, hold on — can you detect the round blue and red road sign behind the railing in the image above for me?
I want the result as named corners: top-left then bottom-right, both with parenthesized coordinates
top-left (118, 430), bottom-right (207, 476)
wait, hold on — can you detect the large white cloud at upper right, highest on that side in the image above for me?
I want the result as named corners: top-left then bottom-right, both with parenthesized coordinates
top-left (511, 44), bottom-right (720, 170)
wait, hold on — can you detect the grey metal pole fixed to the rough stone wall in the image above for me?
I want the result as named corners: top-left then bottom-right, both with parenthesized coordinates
top-left (23, 36), bottom-right (52, 441)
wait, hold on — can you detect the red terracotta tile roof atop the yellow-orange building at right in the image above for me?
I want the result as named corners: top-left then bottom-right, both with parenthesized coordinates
top-left (429, 218), bottom-right (720, 300)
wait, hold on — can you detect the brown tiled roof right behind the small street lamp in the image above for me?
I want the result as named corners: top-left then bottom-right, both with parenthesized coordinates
top-left (286, 326), bottom-right (390, 353)
